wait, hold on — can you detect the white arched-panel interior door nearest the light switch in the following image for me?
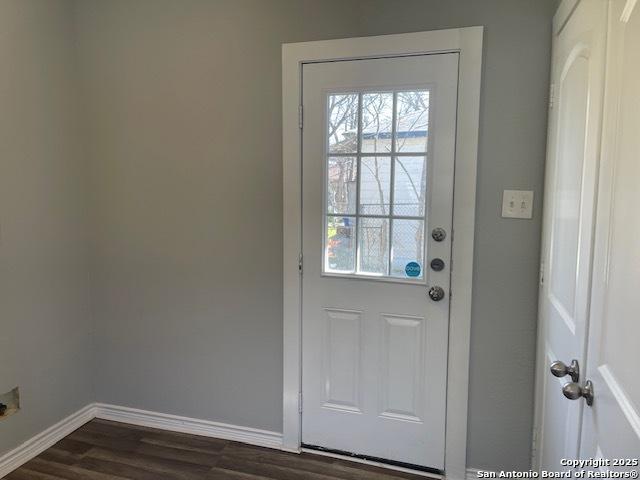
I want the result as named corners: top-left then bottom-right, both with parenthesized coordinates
top-left (536, 0), bottom-right (607, 470)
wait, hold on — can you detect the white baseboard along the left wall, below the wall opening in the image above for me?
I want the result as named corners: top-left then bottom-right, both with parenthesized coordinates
top-left (0, 404), bottom-right (96, 478)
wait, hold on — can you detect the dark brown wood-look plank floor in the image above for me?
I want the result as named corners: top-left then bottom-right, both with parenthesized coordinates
top-left (5, 420), bottom-right (425, 480)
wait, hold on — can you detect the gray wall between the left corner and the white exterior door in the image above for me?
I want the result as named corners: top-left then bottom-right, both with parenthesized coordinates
top-left (77, 0), bottom-right (358, 431)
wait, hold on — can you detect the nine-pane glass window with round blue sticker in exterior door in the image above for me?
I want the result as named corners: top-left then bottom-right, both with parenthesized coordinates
top-left (323, 90), bottom-right (429, 281)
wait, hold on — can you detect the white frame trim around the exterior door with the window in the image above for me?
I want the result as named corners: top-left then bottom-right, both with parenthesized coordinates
top-left (282, 27), bottom-right (484, 480)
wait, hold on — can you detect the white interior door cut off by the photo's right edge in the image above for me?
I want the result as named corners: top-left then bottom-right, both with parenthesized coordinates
top-left (581, 0), bottom-right (640, 464)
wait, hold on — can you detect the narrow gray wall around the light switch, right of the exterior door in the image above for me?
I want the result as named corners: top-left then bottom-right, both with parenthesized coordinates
top-left (361, 0), bottom-right (557, 468)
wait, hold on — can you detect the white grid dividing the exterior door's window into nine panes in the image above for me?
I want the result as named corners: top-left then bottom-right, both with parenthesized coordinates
top-left (322, 89), bottom-right (431, 282)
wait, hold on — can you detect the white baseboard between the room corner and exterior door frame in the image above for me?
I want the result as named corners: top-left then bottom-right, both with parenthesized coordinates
top-left (96, 403), bottom-right (282, 449)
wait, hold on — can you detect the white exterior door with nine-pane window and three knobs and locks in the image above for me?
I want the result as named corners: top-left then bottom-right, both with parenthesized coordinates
top-left (302, 54), bottom-right (458, 470)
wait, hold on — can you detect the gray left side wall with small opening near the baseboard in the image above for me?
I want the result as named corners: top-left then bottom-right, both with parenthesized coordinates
top-left (0, 0), bottom-right (93, 453)
